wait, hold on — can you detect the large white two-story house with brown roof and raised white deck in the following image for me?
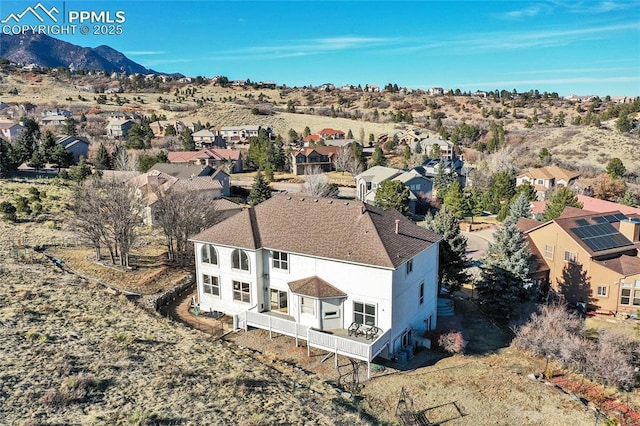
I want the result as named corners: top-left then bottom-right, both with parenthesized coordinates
top-left (191, 195), bottom-right (440, 372)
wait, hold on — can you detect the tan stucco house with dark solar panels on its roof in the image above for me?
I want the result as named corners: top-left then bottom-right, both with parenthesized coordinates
top-left (518, 207), bottom-right (640, 315)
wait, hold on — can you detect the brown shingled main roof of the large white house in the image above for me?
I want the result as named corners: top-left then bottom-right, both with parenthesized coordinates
top-left (192, 195), bottom-right (441, 268)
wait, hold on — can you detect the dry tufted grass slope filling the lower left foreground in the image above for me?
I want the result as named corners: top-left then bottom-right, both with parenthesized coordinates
top-left (0, 259), bottom-right (363, 425)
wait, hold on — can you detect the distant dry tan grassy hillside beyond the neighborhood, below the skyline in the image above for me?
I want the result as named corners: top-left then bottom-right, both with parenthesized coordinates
top-left (0, 73), bottom-right (640, 174)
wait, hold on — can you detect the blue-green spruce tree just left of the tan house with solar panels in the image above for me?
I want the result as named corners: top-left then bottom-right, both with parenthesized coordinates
top-left (476, 218), bottom-right (533, 320)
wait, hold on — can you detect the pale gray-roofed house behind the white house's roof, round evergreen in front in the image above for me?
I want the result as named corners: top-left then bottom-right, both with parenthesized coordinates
top-left (355, 166), bottom-right (433, 213)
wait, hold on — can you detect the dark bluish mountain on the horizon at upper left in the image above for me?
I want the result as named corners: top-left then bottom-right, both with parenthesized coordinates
top-left (0, 32), bottom-right (152, 74)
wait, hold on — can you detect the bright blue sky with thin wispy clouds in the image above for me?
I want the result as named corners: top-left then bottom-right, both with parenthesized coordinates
top-left (0, 0), bottom-right (640, 96)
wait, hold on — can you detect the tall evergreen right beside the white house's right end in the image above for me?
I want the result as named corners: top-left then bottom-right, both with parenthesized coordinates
top-left (424, 206), bottom-right (469, 294)
